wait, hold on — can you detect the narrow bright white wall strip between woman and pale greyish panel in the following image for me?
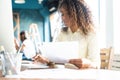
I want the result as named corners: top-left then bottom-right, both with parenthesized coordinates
top-left (99, 0), bottom-right (106, 48)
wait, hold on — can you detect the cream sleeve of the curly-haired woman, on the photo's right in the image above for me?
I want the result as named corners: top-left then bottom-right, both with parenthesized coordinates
top-left (87, 34), bottom-right (101, 68)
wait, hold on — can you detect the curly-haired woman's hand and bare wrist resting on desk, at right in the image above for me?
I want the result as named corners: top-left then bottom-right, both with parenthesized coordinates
top-left (69, 59), bottom-right (91, 69)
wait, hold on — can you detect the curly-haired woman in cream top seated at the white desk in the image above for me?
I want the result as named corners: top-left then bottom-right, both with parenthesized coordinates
top-left (32, 0), bottom-right (100, 69)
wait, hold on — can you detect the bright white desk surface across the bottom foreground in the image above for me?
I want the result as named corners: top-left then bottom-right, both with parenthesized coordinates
top-left (0, 68), bottom-right (120, 80)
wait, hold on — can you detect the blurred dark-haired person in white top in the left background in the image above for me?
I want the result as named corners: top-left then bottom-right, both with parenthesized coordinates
top-left (20, 31), bottom-right (36, 60)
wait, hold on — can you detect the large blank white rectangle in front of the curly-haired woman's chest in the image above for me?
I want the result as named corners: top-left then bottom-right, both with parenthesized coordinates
top-left (41, 42), bottom-right (79, 63)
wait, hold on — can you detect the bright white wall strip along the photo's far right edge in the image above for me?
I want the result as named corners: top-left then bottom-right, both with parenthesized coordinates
top-left (113, 0), bottom-right (120, 54)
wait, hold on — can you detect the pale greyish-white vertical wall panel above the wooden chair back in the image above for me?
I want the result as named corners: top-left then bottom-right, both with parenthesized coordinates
top-left (106, 0), bottom-right (114, 47)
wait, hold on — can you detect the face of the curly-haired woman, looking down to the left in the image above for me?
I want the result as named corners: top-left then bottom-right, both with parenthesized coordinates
top-left (60, 8), bottom-right (71, 27)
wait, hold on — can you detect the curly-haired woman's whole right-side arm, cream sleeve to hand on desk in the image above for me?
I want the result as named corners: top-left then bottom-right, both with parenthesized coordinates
top-left (69, 34), bottom-right (100, 69)
